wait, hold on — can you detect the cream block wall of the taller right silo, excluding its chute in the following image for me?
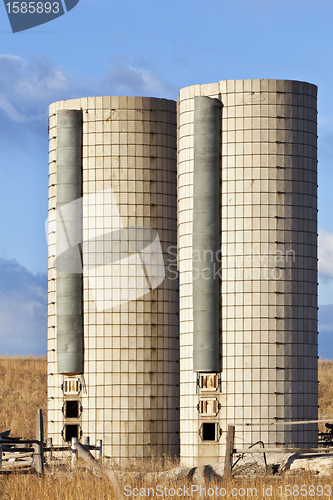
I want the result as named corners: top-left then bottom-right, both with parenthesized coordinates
top-left (178, 80), bottom-right (317, 465)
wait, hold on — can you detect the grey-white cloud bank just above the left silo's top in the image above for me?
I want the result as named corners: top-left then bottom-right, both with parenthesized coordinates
top-left (0, 54), bottom-right (177, 126)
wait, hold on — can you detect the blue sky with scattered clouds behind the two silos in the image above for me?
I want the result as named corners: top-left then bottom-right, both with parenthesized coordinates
top-left (0, 0), bottom-right (333, 359)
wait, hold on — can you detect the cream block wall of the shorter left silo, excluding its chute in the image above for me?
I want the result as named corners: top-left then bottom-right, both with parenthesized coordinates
top-left (48, 96), bottom-right (179, 460)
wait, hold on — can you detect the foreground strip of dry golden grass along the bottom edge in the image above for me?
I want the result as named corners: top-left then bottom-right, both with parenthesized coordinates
top-left (0, 469), bottom-right (333, 500)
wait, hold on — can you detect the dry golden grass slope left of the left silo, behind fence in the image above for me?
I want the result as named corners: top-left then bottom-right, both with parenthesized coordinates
top-left (0, 356), bottom-right (47, 439)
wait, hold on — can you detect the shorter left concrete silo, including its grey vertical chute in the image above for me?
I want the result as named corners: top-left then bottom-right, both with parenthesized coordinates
top-left (48, 97), bottom-right (179, 459)
